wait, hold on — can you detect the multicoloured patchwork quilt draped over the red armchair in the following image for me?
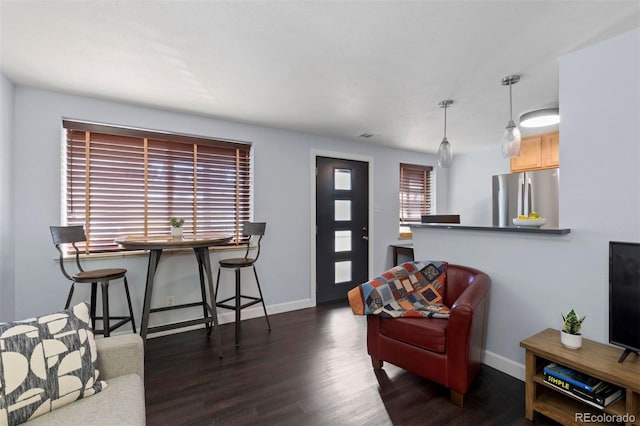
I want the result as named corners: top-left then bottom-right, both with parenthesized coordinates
top-left (348, 261), bottom-right (450, 318)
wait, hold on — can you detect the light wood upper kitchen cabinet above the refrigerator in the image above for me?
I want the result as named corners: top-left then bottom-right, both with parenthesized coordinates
top-left (511, 131), bottom-right (560, 172)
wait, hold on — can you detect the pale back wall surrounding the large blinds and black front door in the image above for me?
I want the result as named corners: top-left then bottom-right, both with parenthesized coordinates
top-left (13, 87), bottom-right (442, 324)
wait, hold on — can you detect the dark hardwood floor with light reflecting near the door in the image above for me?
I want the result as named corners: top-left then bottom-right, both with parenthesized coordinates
top-left (145, 304), bottom-right (553, 425)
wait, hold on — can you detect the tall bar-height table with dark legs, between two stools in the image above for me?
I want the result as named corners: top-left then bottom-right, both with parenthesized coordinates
top-left (116, 234), bottom-right (231, 358)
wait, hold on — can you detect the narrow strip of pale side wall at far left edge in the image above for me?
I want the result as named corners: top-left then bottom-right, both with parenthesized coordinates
top-left (0, 73), bottom-right (15, 321)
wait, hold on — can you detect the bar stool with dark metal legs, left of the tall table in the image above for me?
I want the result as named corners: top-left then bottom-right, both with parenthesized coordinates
top-left (49, 226), bottom-right (136, 337)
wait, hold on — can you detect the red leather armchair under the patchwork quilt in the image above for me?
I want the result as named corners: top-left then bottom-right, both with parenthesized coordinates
top-left (367, 264), bottom-right (491, 407)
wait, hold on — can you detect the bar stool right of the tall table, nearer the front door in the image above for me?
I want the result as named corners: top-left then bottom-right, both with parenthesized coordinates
top-left (216, 222), bottom-right (271, 347)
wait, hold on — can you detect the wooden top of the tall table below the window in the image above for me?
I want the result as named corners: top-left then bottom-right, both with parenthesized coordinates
top-left (115, 234), bottom-right (232, 250)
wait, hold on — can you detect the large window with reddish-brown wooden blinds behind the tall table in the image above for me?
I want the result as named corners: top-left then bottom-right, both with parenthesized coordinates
top-left (63, 120), bottom-right (251, 253)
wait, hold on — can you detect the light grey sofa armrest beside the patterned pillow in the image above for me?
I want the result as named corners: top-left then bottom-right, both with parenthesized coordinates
top-left (96, 334), bottom-right (144, 380)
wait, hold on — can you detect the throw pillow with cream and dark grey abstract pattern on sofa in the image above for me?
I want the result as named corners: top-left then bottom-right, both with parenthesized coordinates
top-left (0, 303), bottom-right (107, 425)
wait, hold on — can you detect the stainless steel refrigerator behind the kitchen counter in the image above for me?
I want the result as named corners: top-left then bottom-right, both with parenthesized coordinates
top-left (493, 169), bottom-right (560, 228)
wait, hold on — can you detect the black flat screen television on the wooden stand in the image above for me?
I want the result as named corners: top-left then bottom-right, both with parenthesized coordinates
top-left (609, 241), bottom-right (640, 362)
